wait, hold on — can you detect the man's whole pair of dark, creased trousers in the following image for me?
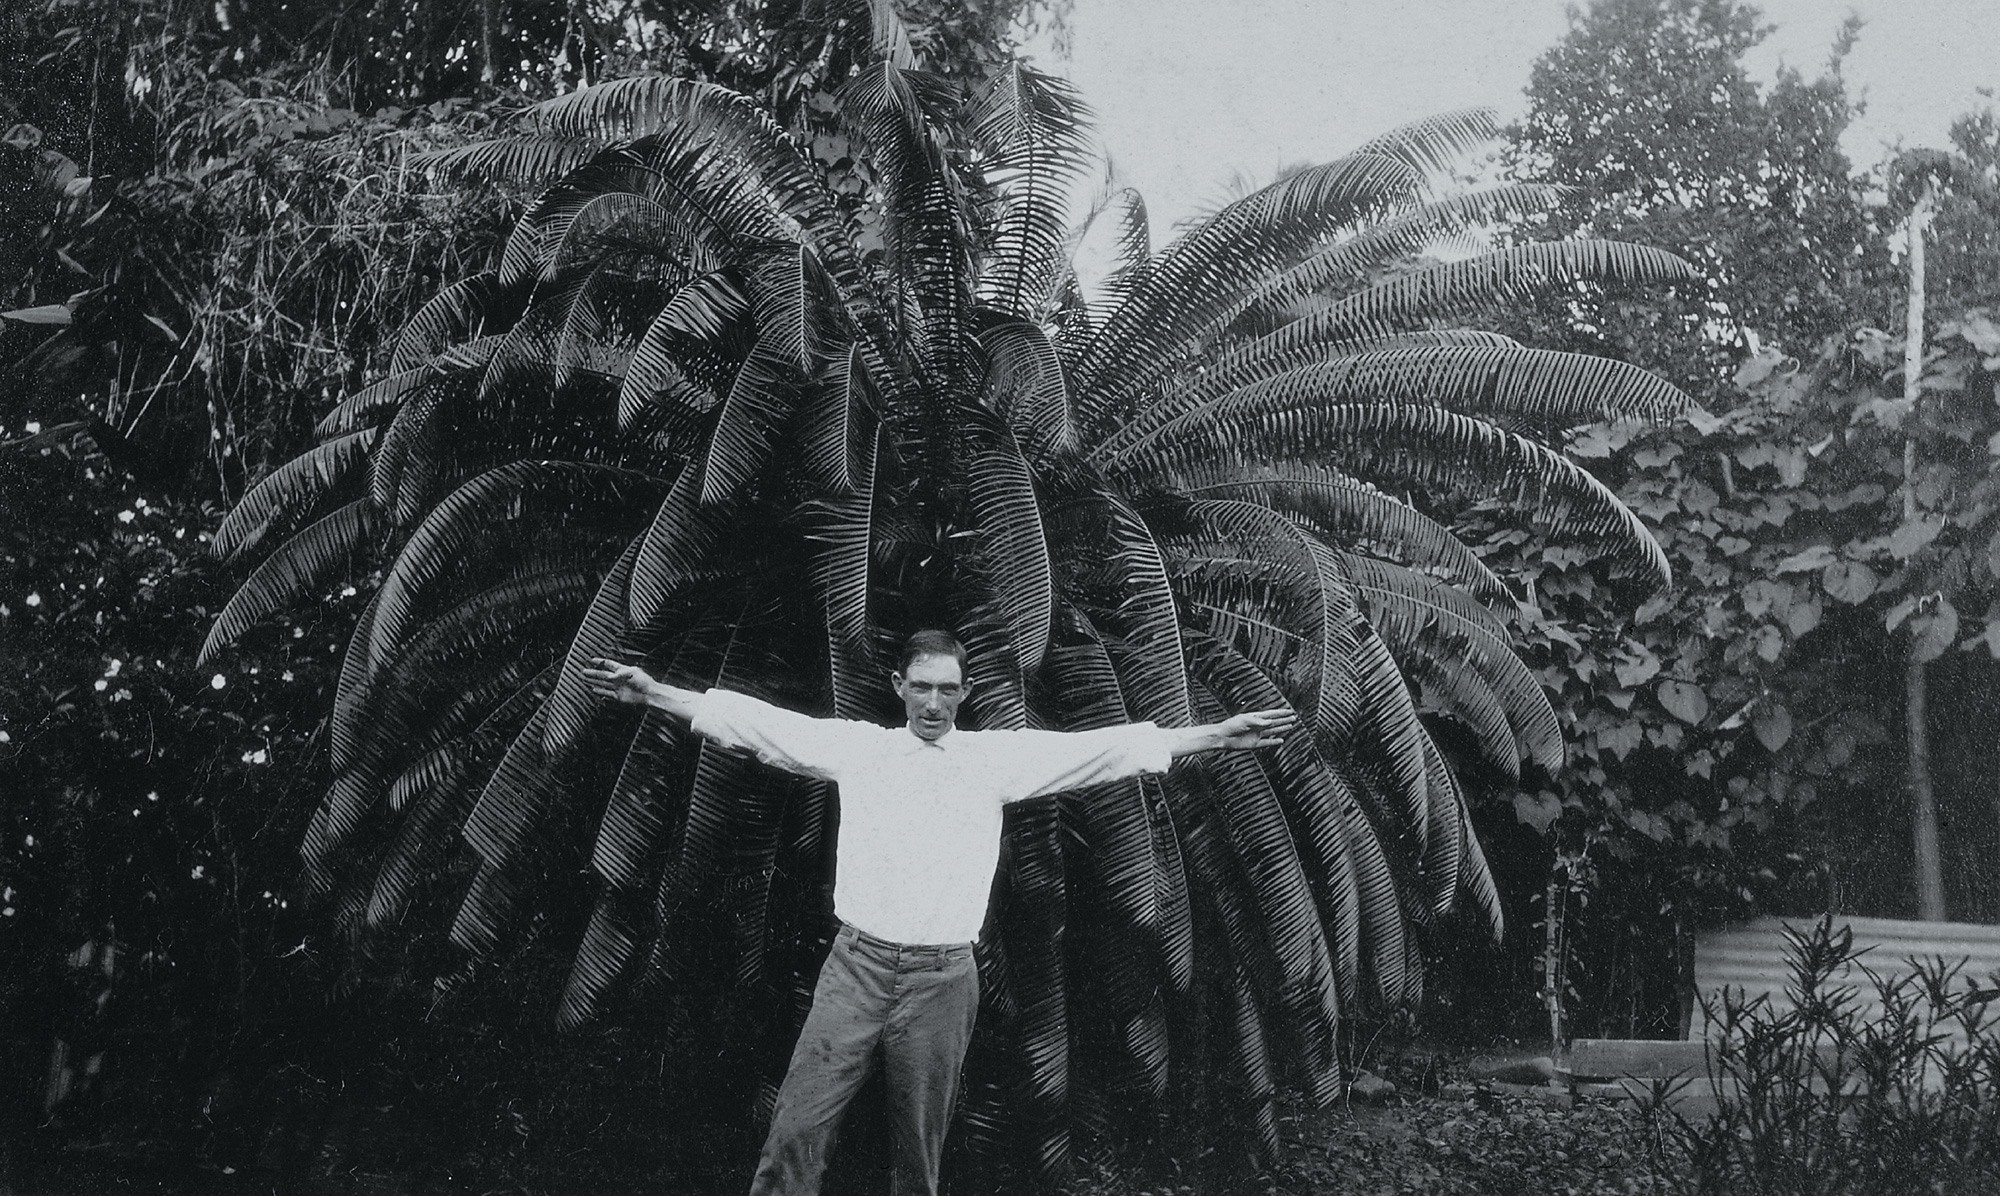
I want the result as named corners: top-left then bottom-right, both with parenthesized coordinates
top-left (750, 926), bottom-right (980, 1196)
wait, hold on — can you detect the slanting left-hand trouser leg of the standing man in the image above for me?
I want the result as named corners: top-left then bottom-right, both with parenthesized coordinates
top-left (750, 930), bottom-right (896, 1196)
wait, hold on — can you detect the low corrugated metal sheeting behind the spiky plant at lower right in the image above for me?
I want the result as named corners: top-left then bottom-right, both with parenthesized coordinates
top-left (1688, 918), bottom-right (2000, 1040)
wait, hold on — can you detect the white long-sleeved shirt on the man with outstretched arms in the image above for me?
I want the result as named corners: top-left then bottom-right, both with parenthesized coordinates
top-left (694, 690), bottom-right (1172, 942)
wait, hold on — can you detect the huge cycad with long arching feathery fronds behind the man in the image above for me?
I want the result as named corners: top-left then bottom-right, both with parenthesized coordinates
top-left (208, 62), bottom-right (1688, 1166)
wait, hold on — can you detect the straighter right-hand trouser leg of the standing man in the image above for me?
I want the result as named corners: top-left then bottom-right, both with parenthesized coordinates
top-left (882, 948), bottom-right (980, 1196)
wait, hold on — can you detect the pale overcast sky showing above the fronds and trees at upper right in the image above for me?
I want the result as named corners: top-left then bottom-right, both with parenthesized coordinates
top-left (1030, 0), bottom-right (2000, 236)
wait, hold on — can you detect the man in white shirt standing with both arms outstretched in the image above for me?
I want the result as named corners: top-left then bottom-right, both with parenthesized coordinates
top-left (584, 632), bottom-right (1296, 1196)
